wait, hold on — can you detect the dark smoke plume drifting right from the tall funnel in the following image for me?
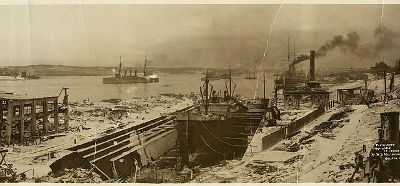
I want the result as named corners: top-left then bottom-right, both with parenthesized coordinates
top-left (293, 26), bottom-right (399, 64)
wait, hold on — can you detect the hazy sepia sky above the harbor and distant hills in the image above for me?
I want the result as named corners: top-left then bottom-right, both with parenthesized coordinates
top-left (0, 3), bottom-right (400, 70)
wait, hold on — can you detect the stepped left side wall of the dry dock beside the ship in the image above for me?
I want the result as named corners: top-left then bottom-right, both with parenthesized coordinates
top-left (50, 107), bottom-right (191, 180)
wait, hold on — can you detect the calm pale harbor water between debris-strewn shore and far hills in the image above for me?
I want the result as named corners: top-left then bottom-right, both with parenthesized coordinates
top-left (0, 72), bottom-right (275, 102)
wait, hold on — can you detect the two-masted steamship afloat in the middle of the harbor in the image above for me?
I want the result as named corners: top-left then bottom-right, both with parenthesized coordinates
top-left (103, 56), bottom-right (159, 84)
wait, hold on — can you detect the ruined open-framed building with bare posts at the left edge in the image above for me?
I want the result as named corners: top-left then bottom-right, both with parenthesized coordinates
top-left (0, 88), bottom-right (69, 145)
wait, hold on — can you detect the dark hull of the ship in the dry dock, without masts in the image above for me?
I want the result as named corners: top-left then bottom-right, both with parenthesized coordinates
top-left (177, 112), bottom-right (261, 166)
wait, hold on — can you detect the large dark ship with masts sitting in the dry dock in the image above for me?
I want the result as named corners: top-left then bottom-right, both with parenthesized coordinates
top-left (176, 69), bottom-right (268, 166)
